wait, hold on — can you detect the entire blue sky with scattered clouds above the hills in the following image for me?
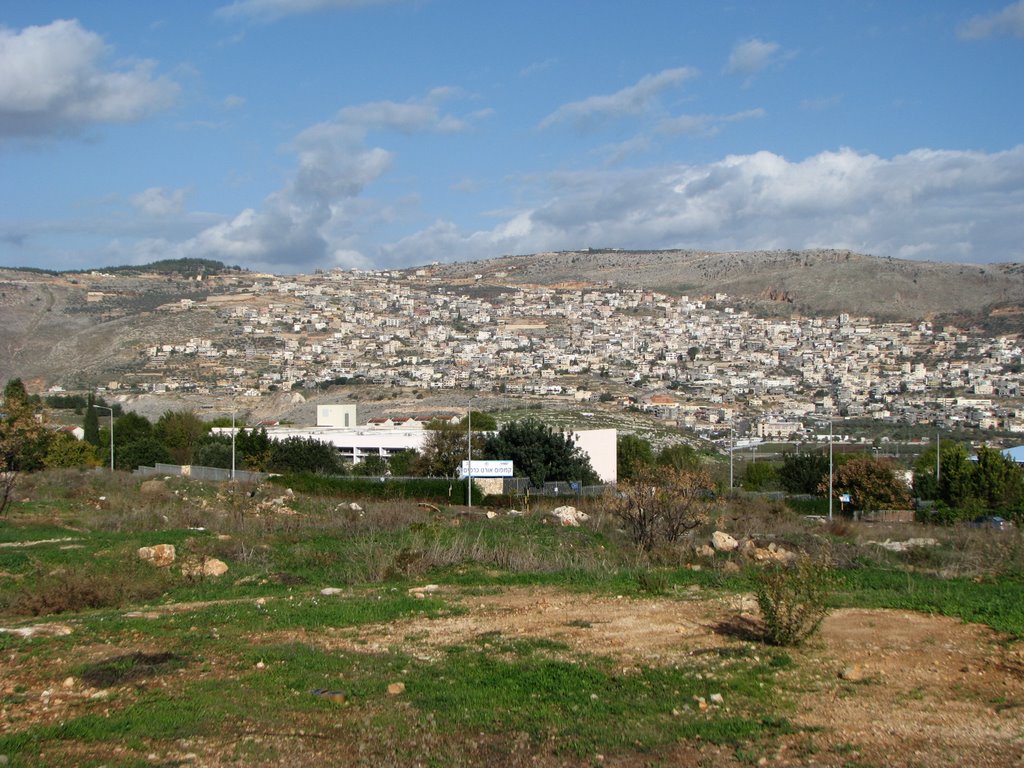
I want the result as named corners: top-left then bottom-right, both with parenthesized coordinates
top-left (0, 0), bottom-right (1024, 273)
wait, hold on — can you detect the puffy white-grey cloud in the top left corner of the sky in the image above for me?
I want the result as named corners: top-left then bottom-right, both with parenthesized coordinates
top-left (0, 19), bottom-right (178, 137)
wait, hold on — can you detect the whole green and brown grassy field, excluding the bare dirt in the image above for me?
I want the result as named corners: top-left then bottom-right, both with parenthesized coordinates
top-left (0, 472), bottom-right (1024, 766)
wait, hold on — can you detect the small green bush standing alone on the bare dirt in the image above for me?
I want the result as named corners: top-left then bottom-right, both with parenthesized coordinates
top-left (755, 556), bottom-right (834, 646)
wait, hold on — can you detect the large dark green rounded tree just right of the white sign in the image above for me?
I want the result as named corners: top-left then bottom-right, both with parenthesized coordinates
top-left (484, 418), bottom-right (600, 485)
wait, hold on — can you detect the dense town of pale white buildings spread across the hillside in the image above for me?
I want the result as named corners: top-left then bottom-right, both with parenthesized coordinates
top-left (77, 267), bottom-right (1024, 438)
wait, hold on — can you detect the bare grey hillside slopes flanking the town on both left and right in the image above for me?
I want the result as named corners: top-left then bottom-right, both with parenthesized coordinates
top-left (0, 250), bottom-right (1024, 388)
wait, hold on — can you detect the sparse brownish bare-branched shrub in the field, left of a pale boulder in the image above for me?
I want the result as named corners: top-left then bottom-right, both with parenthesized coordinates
top-left (611, 467), bottom-right (715, 552)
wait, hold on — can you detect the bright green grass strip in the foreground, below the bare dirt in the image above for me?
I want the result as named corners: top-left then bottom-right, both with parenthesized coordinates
top-left (0, 636), bottom-right (792, 764)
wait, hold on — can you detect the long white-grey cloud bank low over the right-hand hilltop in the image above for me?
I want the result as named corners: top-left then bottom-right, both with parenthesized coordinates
top-left (381, 145), bottom-right (1024, 264)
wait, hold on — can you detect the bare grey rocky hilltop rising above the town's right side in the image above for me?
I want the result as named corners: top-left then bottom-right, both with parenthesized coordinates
top-left (435, 250), bottom-right (1024, 330)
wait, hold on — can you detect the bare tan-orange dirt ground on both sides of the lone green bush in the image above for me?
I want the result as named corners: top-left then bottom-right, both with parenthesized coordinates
top-left (313, 589), bottom-right (1024, 767)
